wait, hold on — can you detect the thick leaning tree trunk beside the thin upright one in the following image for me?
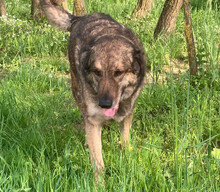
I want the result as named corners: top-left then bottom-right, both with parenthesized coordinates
top-left (154, 0), bottom-right (183, 39)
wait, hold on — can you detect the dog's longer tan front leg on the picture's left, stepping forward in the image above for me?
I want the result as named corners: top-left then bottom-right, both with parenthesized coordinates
top-left (85, 120), bottom-right (104, 178)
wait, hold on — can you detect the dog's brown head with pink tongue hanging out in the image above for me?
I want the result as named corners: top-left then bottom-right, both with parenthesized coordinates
top-left (81, 38), bottom-right (145, 117)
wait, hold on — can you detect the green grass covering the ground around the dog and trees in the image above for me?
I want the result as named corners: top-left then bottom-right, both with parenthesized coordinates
top-left (0, 0), bottom-right (220, 192)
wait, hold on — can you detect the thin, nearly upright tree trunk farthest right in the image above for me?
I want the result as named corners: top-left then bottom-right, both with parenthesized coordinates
top-left (183, 0), bottom-right (198, 76)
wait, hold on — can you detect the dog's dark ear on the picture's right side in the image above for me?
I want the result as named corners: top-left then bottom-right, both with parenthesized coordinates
top-left (132, 48), bottom-right (145, 74)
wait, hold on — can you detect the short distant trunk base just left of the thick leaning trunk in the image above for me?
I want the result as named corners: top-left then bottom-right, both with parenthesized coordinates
top-left (132, 0), bottom-right (153, 18)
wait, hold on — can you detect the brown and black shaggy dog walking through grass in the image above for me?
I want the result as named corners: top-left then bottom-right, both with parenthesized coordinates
top-left (41, 0), bottom-right (146, 177)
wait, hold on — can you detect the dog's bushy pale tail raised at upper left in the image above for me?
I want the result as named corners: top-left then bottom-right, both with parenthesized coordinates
top-left (41, 0), bottom-right (78, 31)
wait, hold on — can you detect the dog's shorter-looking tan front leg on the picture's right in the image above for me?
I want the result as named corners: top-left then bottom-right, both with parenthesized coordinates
top-left (120, 110), bottom-right (134, 146)
